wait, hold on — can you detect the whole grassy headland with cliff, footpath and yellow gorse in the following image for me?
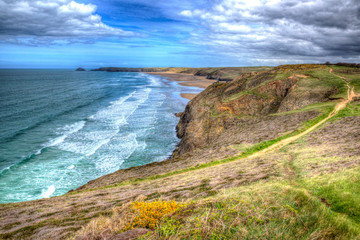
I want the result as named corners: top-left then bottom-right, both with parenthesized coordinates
top-left (0, 64), bottom-right (360, 240)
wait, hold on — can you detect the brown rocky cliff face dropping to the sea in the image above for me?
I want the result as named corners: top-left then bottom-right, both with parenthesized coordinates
top-left (173, 70), bottom-right (336, 157)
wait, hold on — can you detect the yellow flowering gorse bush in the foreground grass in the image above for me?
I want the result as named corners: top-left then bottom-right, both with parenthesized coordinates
top-left (126, 201), bottom-right (184, 230)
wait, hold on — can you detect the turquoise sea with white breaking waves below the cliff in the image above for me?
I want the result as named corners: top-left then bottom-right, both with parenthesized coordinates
top-left (0, 69), bottom-right (201, 203)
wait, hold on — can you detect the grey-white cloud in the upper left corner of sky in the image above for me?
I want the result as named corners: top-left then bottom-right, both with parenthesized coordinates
top-left (0, 0), bottom-right (135, 43)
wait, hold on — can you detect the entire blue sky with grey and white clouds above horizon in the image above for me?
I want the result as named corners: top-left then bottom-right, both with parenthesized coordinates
top-left (0, 0), bottom-right (360, 68)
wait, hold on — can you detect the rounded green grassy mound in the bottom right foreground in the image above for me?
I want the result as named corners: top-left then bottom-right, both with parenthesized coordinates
top-left (152, 182), bottom-right (360, 239)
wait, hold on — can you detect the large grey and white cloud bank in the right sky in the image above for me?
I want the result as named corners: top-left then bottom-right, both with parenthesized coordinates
top-left (180, 0), bottom-right (360, 60)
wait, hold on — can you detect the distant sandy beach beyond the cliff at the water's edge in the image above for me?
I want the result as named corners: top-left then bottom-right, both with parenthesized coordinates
top-left (148, 72), bottom-right (215, 100)
